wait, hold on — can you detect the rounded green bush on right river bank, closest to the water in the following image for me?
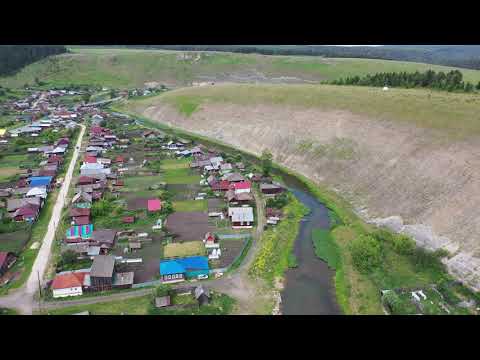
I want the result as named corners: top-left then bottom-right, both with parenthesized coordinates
top-left (350, 235), bottom-right (382, 273)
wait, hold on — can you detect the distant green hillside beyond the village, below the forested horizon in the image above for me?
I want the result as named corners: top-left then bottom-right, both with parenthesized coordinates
top-left (0, 48), bottom-right (480, 88)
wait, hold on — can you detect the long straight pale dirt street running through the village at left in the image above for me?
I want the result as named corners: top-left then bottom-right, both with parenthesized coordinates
top-left (0, 125), bottom-right (85, 314)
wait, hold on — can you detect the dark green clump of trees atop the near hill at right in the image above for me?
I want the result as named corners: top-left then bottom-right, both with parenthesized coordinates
top-left (328, 70), bottom-right (480, 92)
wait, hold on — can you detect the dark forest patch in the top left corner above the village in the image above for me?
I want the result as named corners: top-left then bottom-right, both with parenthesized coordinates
top-left (0, 45), bottom-right (67, 76)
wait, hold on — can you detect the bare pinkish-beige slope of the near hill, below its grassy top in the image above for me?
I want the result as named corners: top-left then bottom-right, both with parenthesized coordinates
top-left (135, 103), bottom-right (480, 289)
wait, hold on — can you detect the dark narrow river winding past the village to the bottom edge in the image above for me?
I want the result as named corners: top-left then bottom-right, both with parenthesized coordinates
top-left (281, 175), bottom-right (341, 315)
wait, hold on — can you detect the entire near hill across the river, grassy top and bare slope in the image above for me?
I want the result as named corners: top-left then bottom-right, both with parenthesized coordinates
top-left (125, 84), bottom-right (480, 289)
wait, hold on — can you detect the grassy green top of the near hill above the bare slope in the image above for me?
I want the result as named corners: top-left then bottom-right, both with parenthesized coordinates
top-left (128, 84), bottom-right (480, 136)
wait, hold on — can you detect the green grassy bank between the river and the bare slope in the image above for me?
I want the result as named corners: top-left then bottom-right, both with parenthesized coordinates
top-left (111, 105), bottom-right (480, 314)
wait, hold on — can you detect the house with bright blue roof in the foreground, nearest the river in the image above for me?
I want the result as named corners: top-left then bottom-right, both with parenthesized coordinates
top-left (160, 256), bottom-right (210, 283)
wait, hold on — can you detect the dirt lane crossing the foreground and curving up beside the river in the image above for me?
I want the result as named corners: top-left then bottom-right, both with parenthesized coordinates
top-left (36, 190), bottom-right (269, 314)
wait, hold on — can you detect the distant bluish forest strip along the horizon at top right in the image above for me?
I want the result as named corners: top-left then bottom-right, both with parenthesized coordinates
top-left (94, 45), bottom-right (480, 69)
